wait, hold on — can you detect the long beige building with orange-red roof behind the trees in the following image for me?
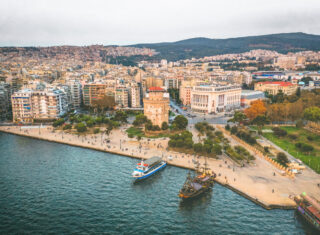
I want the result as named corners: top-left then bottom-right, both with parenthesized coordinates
top-left (254, 81), bottom-right (298, 95)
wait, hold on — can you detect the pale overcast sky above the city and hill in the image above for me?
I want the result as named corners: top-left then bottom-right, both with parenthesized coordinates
top-left (0, 0), bottom-right (320, 46)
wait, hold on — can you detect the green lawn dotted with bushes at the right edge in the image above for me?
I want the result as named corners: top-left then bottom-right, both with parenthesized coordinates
top-left (255, 126), bottom-right (320, 173)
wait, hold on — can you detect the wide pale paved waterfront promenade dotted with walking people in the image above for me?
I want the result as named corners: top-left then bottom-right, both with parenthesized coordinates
top-left (0, 126), bottom-right (320, 209)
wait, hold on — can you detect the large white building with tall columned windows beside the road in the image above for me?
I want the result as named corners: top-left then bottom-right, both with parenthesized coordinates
top-left (191, 84), bottom-right (241, 114)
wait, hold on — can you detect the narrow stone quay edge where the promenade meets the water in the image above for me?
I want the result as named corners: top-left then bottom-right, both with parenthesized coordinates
top-left (0, 129), bottom-right (296, 210)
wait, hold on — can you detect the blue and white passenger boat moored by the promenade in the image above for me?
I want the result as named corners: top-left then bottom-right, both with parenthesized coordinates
top-left (132, 156), bottom-right (167, 180)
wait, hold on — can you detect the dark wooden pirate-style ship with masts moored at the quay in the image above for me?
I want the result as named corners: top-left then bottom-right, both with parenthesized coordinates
top-left (179, 159), bottom-right (216, 200)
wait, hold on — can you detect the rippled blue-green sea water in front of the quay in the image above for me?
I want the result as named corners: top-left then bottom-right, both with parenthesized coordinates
top-left (0, 133), bottom-right (314, 234)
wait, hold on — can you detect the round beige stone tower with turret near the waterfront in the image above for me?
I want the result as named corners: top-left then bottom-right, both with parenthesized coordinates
top-left (143, 87), bottom-right (170, 127)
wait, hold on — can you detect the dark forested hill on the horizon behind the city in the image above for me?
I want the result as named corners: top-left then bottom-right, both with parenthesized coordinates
top-left (130, 33), bottom-right (320, 61)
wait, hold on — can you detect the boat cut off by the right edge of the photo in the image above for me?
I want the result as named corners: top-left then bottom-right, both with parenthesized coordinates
top-left (294, 193), bottom-right (320, 231)
